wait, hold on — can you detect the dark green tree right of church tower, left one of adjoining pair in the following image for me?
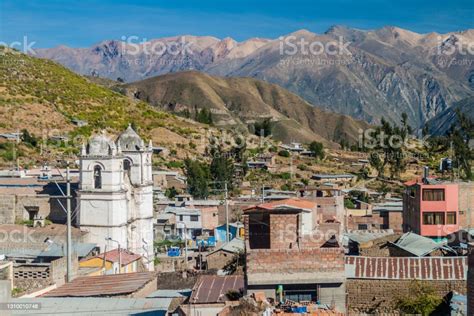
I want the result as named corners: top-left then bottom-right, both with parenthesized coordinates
top-left (184, 159), bottom-right (210, 198)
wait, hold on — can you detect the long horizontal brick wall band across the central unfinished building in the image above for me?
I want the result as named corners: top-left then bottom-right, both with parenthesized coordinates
top-left (246, 248), bottom-right (344, 274)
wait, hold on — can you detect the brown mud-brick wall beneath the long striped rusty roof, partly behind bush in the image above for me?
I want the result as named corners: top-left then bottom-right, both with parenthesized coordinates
top-left (346, 279), bottom-right (464, 315)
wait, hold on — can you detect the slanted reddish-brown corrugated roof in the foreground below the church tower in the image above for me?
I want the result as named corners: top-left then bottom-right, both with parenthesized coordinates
top-left (43, 272), bottom-right (156, 297)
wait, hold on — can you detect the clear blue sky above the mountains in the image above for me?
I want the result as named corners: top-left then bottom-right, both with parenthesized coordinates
top-left (0, 0), bottom-right (474, 48)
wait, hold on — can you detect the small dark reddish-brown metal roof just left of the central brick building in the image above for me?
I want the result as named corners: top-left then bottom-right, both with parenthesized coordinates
top-left (190, 275), bottom-right (244, 304)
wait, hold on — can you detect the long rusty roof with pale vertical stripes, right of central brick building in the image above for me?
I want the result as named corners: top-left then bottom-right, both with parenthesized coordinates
top-left (345, 256), bottom-right (467, 280)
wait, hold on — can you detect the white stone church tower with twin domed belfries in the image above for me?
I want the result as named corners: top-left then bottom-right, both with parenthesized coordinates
top-left (78, 126), bottom-right (154, 270)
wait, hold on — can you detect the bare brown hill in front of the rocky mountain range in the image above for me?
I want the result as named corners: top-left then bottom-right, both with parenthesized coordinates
top-left (122, 71), bottom-right (369, 143)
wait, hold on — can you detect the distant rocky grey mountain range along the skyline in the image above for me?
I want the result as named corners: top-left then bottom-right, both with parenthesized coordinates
top-left (36, 26), bottom-right (474, 129)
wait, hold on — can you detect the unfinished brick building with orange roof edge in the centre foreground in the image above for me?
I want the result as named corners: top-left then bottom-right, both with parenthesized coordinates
top-left (243, 198), bottom-right (345, 311)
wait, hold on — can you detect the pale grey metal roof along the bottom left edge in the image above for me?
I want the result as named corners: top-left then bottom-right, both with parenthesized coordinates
top-left (9, 297), bottom-right (172, 316)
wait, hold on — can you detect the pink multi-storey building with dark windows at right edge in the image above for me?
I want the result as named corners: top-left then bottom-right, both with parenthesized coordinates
top-left (403, 178), bottom-right (474, 238)
